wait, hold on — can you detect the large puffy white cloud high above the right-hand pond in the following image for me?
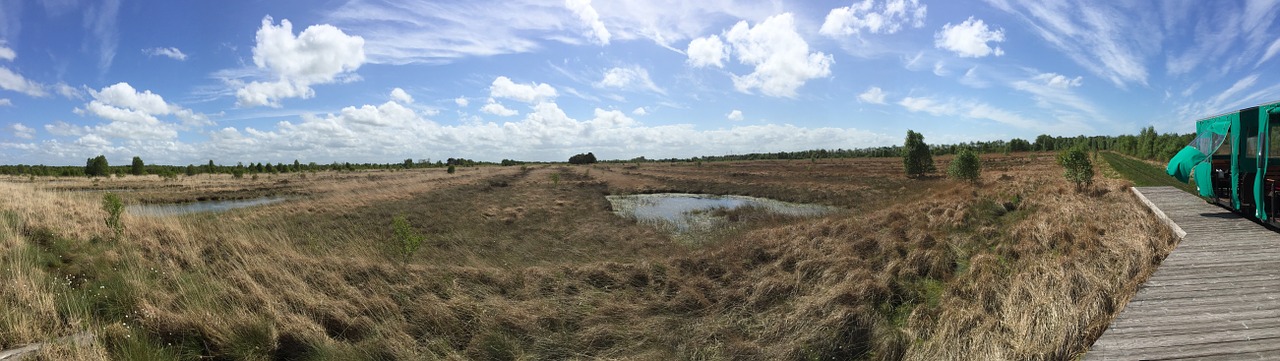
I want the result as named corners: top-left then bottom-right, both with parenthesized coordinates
top-left (724, 13), bottom-right (835, 97)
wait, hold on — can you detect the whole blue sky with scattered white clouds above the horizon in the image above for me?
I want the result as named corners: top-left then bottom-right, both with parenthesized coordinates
top-left (0, 0), bottom-right (1280, 165)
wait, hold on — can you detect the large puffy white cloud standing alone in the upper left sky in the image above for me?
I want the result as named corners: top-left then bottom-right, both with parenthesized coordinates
top-left (236, 17), bottom-right (365, 108)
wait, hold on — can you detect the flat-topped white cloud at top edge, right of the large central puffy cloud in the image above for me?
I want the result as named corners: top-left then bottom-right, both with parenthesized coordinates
top-left (818, 0), bottom-right (929, 37)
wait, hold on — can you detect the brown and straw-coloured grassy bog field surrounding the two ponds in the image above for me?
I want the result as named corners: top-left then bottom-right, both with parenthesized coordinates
top-left (0, 154), bottom-right (1176, 360)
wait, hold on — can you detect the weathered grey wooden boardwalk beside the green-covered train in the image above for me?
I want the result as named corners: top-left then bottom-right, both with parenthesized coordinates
top-left (1085, 187), bottom-right (1280, 360)
